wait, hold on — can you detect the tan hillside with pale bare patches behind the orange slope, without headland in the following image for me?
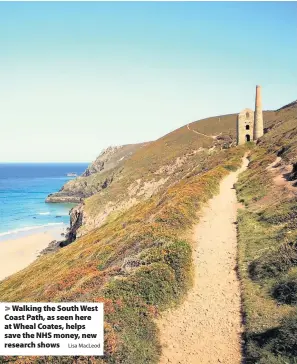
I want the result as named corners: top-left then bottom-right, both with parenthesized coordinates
top-left (65, 112), bottom-right (271, 236)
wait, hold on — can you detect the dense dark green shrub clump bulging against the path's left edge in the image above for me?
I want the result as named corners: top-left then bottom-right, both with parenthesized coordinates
top-left (104, 241), bottom-right (192, 306)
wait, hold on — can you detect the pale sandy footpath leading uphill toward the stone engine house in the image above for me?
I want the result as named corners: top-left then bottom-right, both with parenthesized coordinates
top-left (158, 156), bottom-right (248, 364)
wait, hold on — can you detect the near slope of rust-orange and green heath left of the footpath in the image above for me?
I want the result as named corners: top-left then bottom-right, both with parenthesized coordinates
top-left (0, 139), bottom-right (245, 364)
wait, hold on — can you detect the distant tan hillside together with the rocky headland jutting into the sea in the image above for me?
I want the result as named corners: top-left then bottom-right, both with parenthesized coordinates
top-left (49, 112), bottom-right (254, 237)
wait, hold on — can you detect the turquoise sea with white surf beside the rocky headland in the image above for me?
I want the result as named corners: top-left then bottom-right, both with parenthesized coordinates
top-left (0, 163), bottom-right (88, 240)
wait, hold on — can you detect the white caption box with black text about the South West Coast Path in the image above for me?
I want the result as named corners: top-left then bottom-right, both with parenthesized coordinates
top-left (0, 302), bottom-right (104, 356)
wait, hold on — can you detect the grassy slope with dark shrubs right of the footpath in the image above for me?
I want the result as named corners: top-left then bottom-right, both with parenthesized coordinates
top-left (236, 103), bottom-right (297, 364)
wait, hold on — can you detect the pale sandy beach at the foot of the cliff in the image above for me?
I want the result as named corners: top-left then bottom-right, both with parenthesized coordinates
top-left (0, 226), bottom-right (65, 280)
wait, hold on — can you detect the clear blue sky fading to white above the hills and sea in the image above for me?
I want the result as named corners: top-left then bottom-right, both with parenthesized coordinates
top-left (0, 2), bottom-right (297, 162)
